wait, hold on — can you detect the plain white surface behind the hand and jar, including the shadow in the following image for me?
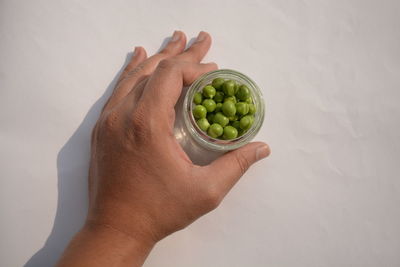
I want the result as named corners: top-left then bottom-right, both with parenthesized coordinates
top-left (0, 0), bottom-right (400, 267)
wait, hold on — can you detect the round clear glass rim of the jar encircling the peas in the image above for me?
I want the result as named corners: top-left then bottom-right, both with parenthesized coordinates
top-left (182, 69), bottom-right (265, 151)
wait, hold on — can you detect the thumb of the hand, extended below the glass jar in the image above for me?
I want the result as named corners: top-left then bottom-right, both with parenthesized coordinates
top-left (207, 142), bottom-right (271, 195)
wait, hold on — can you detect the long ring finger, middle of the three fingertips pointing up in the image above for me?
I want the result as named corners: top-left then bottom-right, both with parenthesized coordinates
top-left (104, 31), bottom-right (186, 113)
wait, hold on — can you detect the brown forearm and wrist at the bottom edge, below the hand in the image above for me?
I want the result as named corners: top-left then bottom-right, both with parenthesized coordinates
top-left (57, 225), bottom-right (154, 267)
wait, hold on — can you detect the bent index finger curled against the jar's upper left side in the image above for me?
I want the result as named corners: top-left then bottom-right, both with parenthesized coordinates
top-left (141, 59), bottom-right (218, 115)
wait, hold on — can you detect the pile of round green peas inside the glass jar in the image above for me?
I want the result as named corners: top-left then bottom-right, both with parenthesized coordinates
top-left (193, 78), bottom-right (256, 140)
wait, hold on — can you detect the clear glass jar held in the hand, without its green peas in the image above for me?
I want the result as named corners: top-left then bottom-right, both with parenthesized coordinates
top-left (174, 69), bottom-right (264, 164)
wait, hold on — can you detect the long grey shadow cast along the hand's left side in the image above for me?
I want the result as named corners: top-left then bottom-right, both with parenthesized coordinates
top-left (25, 53), bottom-right (132, 267)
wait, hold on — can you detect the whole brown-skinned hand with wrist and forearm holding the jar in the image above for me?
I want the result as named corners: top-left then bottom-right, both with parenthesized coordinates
top-left (57, 31), bottom-right (270, 267)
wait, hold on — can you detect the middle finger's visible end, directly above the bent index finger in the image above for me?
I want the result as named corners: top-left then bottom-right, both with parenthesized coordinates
top-left (177, 31), bottom-right (211, 62)
